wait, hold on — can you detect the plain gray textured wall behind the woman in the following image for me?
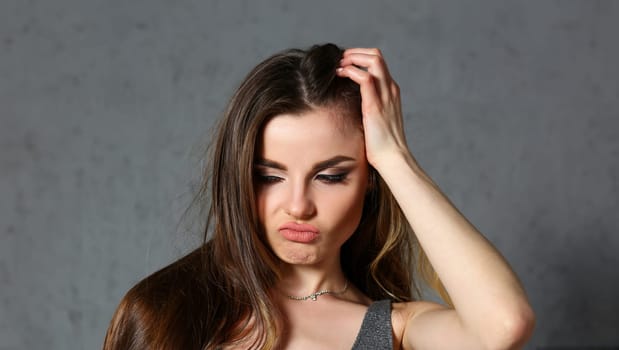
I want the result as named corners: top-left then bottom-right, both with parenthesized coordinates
top-left (0, 0), bottom-right (619, 350)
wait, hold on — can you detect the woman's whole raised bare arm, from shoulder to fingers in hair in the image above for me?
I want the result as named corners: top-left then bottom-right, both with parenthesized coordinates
top-left (337, 48), bottom-right (535, 349)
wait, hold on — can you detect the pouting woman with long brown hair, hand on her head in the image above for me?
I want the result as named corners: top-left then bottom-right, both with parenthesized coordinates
top-left (104, 44), bottom-right (534, 349)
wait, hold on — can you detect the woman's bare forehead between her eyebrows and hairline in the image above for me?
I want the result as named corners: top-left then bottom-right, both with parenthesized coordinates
top-left (258, 108), bottom-right (365, 161)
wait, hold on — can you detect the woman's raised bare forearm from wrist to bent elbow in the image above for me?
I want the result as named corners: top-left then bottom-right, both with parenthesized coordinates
top-left (376, 153), bottom-right (532, 344)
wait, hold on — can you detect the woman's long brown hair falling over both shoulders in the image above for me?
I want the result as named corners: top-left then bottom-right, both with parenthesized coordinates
top-left (104, 44), bottom-right (444, 350)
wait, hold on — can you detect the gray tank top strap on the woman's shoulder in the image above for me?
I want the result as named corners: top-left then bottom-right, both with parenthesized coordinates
top-left (352, 299), bottom-right (393, 350)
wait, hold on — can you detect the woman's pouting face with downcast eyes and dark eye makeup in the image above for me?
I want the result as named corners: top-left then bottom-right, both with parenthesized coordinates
top-left (254, 109), bottom-right (368, 265)
